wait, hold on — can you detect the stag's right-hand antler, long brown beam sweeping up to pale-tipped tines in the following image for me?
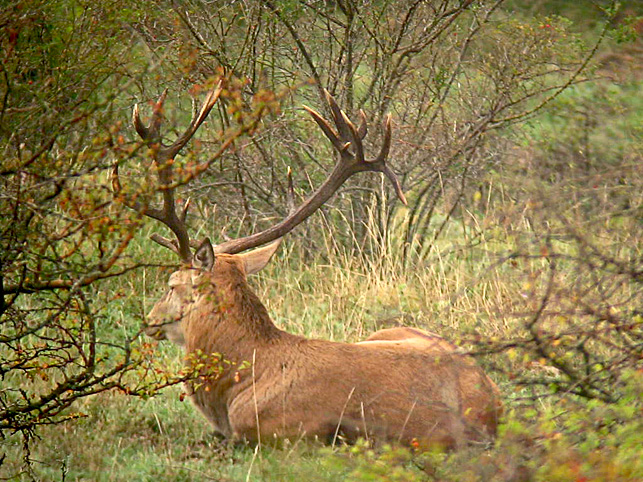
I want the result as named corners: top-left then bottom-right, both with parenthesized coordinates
top-left (214, 93), bottom-right (406, 254)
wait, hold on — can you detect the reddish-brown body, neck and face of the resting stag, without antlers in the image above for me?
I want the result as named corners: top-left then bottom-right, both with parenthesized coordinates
top-left (148, 255), bottom-right (499, 447)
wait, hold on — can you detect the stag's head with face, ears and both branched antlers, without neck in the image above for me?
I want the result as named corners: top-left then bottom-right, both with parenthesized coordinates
top-left (112, 83), bottom-right (406, 338)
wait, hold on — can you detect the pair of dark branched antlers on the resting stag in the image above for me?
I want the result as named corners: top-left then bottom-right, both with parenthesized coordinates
top-left (112, 83), bottom-right (406, 263)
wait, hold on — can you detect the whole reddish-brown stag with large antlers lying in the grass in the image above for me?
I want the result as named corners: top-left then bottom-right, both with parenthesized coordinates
top-left (119, 84), bottom-right (501, 448)
